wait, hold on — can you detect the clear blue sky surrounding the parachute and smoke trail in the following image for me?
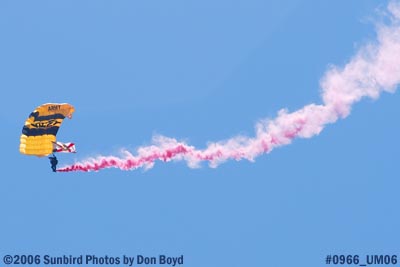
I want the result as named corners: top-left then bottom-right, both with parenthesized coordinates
top-left (0, 0), bottom-right (400, 267)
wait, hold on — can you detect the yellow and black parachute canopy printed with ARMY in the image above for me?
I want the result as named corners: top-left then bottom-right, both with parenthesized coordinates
top-left (19, 103), bottom-right (75, 156)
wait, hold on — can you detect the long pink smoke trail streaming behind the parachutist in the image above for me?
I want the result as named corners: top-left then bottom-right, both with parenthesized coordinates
top-left (58, 1), bottom-right (400, 172)
